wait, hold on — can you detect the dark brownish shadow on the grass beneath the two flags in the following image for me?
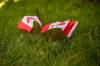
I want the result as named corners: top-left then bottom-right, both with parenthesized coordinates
top-left (30, 26), bottom-right (74, 46)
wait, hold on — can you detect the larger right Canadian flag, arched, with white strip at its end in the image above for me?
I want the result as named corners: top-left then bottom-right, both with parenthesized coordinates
top-left (41, 20), bottom-right (78, 37)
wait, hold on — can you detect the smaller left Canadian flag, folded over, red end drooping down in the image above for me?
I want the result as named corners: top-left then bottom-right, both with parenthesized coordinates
top-left (18, 16), bottom-right (42, 32)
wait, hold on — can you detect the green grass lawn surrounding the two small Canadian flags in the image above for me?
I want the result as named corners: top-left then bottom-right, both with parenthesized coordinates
top-left (0, 0), bottom-right (100, 66)
